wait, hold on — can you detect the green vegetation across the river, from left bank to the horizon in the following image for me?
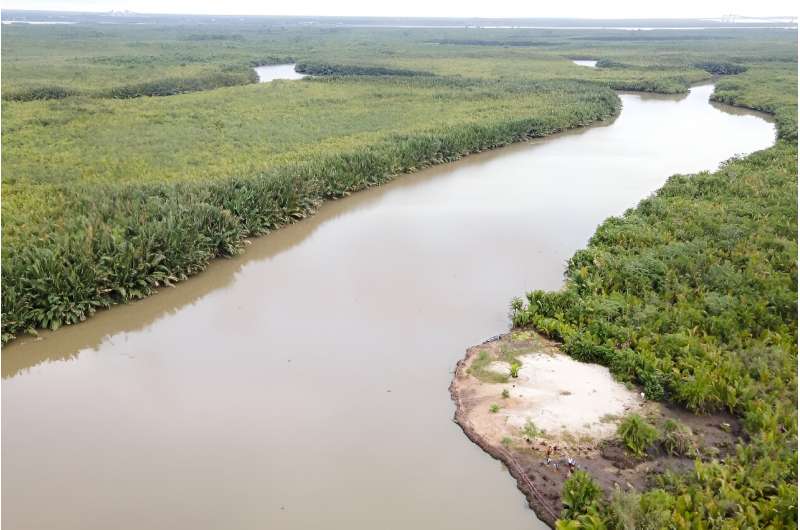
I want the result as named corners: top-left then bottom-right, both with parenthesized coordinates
top-left (2, 17), bottom-right (796, 342)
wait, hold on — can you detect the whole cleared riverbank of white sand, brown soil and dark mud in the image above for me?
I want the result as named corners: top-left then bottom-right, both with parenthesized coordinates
top-left (450, 330), bottom-right (741, 526)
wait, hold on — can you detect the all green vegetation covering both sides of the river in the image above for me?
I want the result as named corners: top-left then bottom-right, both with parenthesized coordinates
top-left (2, 18), bottom-right (797, 528)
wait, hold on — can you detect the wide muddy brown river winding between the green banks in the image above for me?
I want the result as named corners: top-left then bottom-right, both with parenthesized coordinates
top-left (2, 86), bottom-right (774, 530)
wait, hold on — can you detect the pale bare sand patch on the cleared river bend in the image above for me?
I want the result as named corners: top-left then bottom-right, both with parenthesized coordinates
top-left (458, 332), bottom-right (644, 445)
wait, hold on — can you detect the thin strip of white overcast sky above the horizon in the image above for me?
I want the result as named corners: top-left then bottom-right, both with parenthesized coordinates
top-left (3, 0), bottom-right (798, 18)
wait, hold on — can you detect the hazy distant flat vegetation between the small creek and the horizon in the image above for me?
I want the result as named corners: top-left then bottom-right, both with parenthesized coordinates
top-left (2, 17), bottom-right (796, 99)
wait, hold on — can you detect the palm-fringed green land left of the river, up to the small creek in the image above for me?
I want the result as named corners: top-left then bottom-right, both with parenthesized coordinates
top-left (2, 78), bottom-right (619, 343)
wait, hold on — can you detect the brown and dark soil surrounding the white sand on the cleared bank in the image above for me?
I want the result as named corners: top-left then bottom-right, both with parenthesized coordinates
top-left (450, 331), bottom-right (740, 526)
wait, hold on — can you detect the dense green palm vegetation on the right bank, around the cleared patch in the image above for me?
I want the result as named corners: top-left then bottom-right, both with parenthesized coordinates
top-left (513, 63), bottom-right (798, 528)
